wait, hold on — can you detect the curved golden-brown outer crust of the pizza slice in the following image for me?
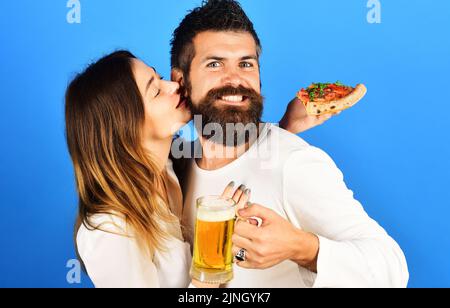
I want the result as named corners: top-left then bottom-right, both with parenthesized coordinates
top-left (302, 84), bottom-right (367, 115)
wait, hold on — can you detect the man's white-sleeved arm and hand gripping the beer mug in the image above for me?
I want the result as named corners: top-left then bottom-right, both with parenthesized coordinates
top-left (233, 147), bottom-right (409, 287)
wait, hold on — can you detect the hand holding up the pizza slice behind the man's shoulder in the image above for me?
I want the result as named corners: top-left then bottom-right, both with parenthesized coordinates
top-left (280, 98), bottom-right (341, 134)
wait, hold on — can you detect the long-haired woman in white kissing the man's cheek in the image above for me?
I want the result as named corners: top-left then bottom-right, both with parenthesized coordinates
top-left (65, 51), bottom-right (253, 287)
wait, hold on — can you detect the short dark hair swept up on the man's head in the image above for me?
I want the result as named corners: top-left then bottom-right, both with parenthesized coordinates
top-left (171, 0), bottom-right (262, 76)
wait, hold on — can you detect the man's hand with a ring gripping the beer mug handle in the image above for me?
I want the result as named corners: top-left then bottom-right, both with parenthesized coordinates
top-left (232, 204), bottom-right (319, 272)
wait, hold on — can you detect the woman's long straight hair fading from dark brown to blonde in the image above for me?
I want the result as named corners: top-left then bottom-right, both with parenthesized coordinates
top-left (65, 51), bottom-right (176, 255)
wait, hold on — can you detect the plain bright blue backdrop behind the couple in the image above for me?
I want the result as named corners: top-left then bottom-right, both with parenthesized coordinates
top-left (0, 0), bottom-right (450, 287)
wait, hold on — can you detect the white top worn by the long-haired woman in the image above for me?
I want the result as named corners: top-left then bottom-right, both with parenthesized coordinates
top-left (77, 161), bottom-right (192, 288)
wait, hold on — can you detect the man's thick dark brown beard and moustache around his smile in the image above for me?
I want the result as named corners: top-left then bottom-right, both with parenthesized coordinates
top-left (187, 85), bottom-right (264, 147)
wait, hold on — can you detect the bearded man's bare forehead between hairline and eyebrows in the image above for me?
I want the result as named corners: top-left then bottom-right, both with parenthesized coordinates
top-left (194, 31), bottom-right (256, 58)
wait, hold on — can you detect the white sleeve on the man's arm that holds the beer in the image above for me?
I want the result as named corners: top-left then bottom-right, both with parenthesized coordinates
top-left (283, 146), bottom-right (409, 287)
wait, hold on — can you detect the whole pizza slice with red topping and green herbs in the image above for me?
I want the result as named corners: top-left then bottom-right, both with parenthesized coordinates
top-left (297, 82), bottom-right (367, 115)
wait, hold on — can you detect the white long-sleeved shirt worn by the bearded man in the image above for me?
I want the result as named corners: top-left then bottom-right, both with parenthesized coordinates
top-left (182, 124), bottom-right (409, 288)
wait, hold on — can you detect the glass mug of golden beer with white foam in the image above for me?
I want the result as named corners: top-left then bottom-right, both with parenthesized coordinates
top-left (191, 196), bottom-right (236, 284)
